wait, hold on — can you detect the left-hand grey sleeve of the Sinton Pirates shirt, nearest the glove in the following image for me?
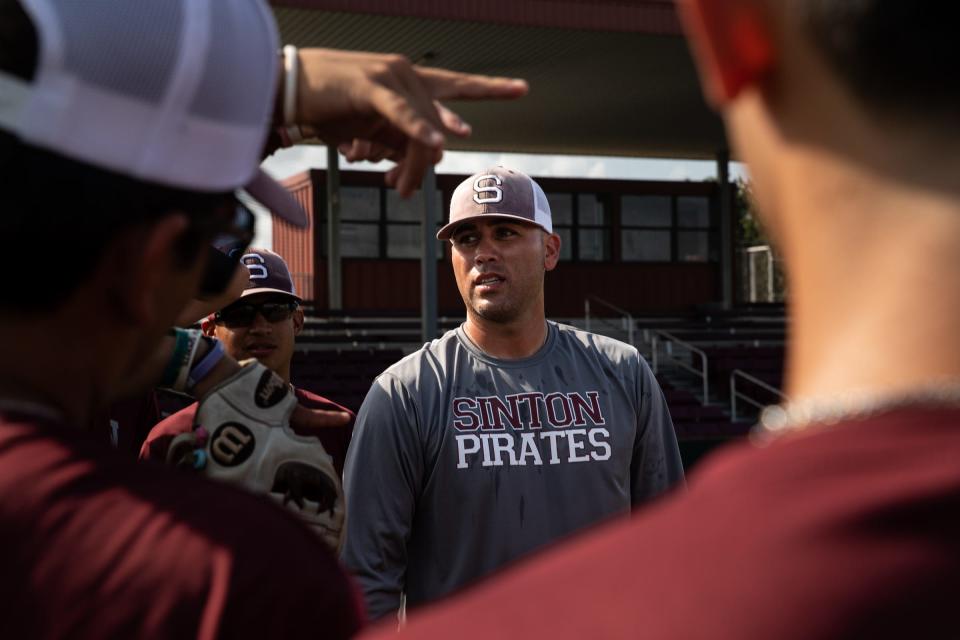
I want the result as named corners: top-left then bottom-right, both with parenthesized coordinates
top-left (341, 374), bottom-right (424, 620)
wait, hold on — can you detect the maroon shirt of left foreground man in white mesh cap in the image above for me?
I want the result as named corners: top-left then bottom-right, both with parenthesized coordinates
top-left (0, 412), bottom-right (362, 639)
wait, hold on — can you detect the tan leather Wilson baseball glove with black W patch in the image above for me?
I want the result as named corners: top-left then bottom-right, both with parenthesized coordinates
top-left (167, 360), bottom-right (344, 551)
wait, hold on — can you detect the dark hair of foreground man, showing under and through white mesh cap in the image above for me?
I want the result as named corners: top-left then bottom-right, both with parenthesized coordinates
top-left (0, 0), bottom-right (233, 311)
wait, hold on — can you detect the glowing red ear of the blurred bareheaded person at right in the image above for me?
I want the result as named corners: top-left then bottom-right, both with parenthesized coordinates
top-left (677, 0), bottom-right (778, 108)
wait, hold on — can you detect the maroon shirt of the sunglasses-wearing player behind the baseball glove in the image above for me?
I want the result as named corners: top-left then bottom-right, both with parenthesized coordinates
top-left (140, 388), bottom-right (353, 476)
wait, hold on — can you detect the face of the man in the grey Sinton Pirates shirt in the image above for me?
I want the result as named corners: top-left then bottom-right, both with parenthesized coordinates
top-left (450, 218), bottom-right (560, 323)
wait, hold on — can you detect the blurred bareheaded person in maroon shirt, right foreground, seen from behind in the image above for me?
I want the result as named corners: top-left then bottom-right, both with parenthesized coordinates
top-left (366, 0), bottom-right (960, 640)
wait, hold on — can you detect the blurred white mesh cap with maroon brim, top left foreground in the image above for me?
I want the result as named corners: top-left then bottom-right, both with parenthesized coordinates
top-left (0, 0), bottom-right (306, 226)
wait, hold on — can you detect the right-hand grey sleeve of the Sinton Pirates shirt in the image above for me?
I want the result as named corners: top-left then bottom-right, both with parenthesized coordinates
top-left (630, 354), bottom-right (684, 505)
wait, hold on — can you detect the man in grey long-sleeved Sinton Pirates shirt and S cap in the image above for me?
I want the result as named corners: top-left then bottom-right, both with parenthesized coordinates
top-left (343, 167), bottom-right (683, 617)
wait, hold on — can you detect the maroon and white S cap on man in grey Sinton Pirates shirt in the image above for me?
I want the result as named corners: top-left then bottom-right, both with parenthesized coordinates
top-left (437, 167), bottom-right (553, 240)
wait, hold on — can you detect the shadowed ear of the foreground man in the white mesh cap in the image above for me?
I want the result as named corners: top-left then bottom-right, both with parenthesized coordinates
top-left (104, 214), bottom-right (190, 324)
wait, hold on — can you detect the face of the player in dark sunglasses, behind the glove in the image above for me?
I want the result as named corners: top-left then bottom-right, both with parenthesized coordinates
top-left (212, 293), bottom-right (303, 381)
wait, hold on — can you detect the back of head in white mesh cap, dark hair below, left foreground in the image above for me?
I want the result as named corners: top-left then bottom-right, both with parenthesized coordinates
top-left (0, 0), bottom-right (292, 311)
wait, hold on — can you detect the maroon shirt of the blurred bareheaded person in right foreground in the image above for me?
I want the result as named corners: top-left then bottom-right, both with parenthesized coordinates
top-left (372, 409), bottom-right (960, 640)
